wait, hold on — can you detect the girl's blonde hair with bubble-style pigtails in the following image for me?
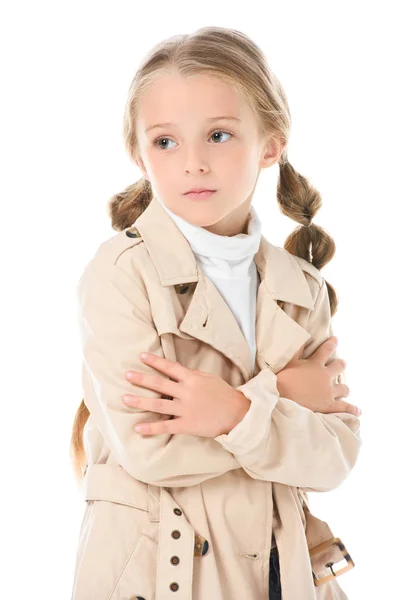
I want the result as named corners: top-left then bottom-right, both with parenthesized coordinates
top-left (71, 27), bottom-right (338, 482)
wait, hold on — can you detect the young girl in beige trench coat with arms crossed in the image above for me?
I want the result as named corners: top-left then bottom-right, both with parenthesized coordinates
top-left (71, 27), bottom-right (361, 600)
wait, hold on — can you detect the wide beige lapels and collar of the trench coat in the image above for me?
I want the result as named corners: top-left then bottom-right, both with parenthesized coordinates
top-left (134, 198), bottom-right (314, 381)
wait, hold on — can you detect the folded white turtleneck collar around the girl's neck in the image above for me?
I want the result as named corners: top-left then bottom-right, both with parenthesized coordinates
top-left (154, 197), bottom-right (261, 262)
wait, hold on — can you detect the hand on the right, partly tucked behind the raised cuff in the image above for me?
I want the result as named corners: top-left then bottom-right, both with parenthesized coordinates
top-left (277, 336), bottom-right (361, 416)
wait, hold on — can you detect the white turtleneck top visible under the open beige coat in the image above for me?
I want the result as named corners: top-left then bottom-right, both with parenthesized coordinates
top-left (155, 198), bottom-right (261, 368)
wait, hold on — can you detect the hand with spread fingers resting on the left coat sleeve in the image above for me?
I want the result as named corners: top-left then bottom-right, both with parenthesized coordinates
top-left (123, 353), bottom-right (251, 437)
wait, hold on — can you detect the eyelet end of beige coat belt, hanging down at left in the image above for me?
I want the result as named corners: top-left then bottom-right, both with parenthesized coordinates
top-left (83, 464), bottom-right (208, 600)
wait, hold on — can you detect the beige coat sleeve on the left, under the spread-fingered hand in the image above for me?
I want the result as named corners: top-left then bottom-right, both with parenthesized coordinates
top-left (76, 260), bottom-right (241, 487)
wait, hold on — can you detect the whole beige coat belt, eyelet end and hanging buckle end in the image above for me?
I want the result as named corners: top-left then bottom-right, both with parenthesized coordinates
top-left (83, 463), bottom-right (354, 600)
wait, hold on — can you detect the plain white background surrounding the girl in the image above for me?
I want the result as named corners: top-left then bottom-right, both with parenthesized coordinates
top-left (0, 0), bottom-right (400, 600)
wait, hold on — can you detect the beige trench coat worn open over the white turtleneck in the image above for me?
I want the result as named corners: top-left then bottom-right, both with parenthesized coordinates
top-left (72, 199), bottom-right (361, 600)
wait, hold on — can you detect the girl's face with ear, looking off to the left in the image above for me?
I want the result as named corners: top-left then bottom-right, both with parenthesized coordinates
top-left (136, 75), bottom-right (281, 235)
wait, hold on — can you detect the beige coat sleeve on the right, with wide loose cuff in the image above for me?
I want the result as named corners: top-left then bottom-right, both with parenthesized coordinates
top-left (214, 279), bottom-right (361, 492)
